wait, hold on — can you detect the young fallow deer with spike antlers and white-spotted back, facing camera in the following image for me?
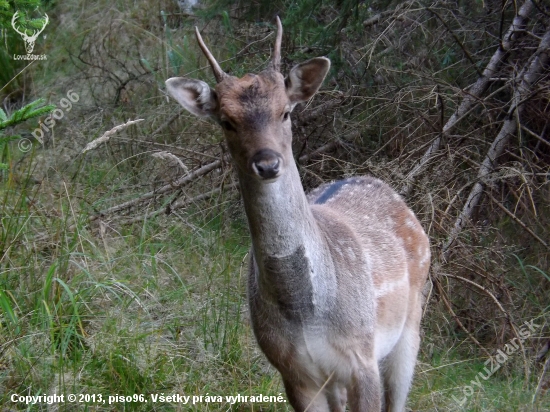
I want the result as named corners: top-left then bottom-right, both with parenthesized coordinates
top-left (166, 18), bottom-right (430, 412)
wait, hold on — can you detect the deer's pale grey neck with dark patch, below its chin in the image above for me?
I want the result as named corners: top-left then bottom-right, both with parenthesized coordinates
top-left (240, 162), bottom-right (331, 322)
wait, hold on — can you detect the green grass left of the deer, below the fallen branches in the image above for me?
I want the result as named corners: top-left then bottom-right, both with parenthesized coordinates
top-left (0, 162), bottom-right (294, 410)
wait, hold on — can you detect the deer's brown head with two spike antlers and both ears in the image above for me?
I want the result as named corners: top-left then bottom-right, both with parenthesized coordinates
top-left (166, 17), bottom-right (330, 182)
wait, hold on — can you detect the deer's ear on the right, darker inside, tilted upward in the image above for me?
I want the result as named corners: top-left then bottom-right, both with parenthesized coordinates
top-left (285, 57), bottom-right (330, 103)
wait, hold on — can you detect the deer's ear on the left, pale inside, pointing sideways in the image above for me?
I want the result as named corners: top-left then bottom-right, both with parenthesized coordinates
top-left (166, 77), bottom-right (218, 117)
